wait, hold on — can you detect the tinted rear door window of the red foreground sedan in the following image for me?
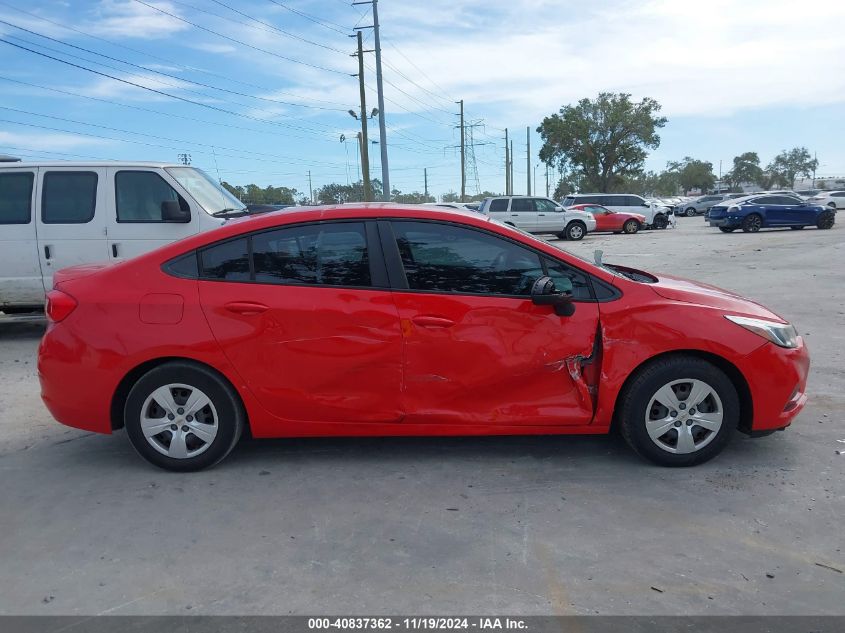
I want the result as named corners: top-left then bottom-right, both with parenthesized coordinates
top-left (252, 222), bottom-right (371, 286)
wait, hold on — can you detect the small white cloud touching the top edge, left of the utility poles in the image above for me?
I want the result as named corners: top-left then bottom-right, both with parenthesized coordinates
top-left (86, 0), bottom-right (190, 39)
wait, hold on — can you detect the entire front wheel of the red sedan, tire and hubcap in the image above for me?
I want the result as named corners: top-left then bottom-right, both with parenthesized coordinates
top-left (618, 356), bottom-right (739, 466)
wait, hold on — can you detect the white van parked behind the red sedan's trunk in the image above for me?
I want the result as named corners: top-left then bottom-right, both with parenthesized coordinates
top-left (0, 162), bottom-right (244, 314)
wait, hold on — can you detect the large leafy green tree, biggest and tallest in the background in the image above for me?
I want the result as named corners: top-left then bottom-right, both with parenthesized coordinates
top-left (537, 92), bottom-right (666, 192)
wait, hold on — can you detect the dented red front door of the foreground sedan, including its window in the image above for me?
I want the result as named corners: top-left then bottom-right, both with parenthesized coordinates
top-left (380, 220), bottom-right (599, 426)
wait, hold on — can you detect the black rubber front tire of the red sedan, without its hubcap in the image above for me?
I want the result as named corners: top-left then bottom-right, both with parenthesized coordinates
top-left (617, 355), bottom-right (740, 466)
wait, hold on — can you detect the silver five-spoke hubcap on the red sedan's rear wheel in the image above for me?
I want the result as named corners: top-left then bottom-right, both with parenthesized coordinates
top-left (141, 383), bottom-right (220, 459)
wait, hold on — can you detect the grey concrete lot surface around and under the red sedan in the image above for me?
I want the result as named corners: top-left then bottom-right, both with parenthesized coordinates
top-left (0, 217), bottom-right (845, 614)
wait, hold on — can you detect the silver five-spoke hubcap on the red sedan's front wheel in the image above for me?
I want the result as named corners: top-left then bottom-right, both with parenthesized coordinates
top-left (645, 378), bottom-right (724, 454)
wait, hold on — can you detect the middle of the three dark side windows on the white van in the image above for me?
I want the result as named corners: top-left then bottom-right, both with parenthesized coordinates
top-left (41, 171), bottom-right (97, 224)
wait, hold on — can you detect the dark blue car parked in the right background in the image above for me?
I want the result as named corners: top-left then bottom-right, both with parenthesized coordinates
top-left (706, 193), bottom-right (836, 233)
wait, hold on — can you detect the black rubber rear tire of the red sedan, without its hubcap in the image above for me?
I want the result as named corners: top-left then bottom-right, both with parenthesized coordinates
top-left (123, 361), bottom-right (246, 472)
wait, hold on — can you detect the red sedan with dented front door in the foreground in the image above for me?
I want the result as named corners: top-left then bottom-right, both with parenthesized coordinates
top-left (38, 205), bottom-right (809, 471)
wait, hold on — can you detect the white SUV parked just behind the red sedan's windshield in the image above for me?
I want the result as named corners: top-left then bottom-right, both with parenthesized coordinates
top-left (478, 196), bottom-right (596, 240)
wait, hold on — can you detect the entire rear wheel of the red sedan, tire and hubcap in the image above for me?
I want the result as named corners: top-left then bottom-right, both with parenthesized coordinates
top-left (123, 362), bottom-right (246, 472)
